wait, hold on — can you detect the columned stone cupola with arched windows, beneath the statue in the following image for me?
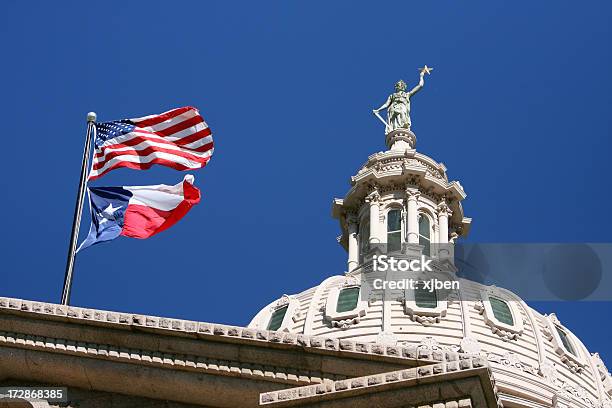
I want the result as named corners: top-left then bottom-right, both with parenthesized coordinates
top-left (332, 124), bottom-right (471, 272)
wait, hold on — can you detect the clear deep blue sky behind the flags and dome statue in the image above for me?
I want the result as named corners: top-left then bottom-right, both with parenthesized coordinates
top-left (0, 1), bottom-right (612, 363)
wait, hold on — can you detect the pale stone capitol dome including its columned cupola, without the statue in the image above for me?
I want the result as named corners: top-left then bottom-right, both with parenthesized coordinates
top-left (249, 129), bottom-right (612, 408)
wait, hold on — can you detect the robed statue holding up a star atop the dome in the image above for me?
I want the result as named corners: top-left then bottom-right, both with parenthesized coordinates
top-left (372, 65), bottom-right (433, 134)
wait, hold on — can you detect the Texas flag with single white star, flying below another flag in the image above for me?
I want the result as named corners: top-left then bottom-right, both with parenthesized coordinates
top-left (77, 175), bottom-right (200, 252)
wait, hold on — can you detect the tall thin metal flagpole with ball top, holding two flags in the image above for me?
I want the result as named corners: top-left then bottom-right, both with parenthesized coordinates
top-left (62, 112), bottom-right (97, 305)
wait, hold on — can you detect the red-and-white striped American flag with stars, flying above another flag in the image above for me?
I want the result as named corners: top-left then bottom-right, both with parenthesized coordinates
top-left (89, 106), bottom-right (214, 180)
